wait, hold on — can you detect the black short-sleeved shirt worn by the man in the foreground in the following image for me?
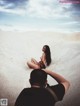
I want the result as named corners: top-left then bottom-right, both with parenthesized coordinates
top-left (15, 84), bottom-right (65, 106)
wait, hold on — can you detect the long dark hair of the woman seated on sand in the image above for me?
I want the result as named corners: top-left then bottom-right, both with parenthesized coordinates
top-left (43, 45), bottom-right (51, 66)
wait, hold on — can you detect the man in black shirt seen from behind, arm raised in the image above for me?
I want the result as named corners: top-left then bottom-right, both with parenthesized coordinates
top-left (15, 69), bottom-right (70, 106)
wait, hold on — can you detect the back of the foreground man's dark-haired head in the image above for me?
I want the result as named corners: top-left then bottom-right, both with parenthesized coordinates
top-left (30, 69), bottom-right (47, 87)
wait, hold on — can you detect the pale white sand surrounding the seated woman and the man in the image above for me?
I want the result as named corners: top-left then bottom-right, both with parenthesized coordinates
top-left (0, 31), bottom-right (80, 106)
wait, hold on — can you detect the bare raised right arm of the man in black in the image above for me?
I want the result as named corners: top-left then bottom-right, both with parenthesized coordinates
top-left (44, 69), bottom-right (70, 92)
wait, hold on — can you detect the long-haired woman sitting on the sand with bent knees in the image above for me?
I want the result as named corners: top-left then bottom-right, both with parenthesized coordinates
top-left (27, 45), bottom-right (51, 69)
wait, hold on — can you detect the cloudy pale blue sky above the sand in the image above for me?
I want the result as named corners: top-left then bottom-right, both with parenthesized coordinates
top-left (0, 0), bottom-right (80, 32)
